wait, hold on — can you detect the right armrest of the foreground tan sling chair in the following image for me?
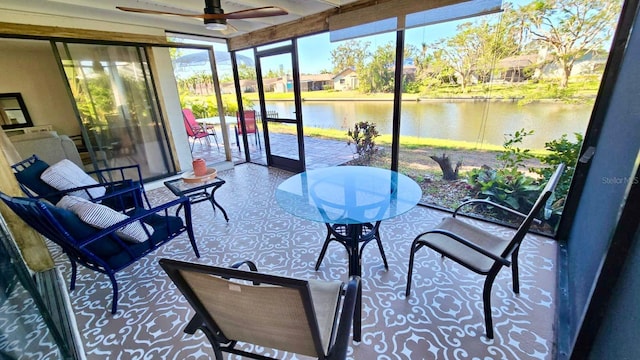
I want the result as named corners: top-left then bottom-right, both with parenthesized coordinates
top-left (327, 276), bottom-right (361, 359)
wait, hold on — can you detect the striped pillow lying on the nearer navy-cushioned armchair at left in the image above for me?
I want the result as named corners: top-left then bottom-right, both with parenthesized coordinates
top-left (56, 195), bottom-right (153, 243)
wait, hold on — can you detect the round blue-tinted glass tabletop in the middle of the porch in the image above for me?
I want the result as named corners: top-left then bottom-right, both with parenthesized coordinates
top-left (276, 166), bottom-right (422, 224)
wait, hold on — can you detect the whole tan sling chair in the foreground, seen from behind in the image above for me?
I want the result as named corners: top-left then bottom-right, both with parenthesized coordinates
top-left (160, 259), bottom-right (360, 360)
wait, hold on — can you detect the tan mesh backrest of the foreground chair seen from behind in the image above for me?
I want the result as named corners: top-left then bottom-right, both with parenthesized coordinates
top-left (160, 259), bottom-right (341, 358)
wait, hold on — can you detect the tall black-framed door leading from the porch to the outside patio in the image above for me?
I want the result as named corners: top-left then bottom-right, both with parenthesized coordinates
top-left (256, 43), bottom-right (305, 172)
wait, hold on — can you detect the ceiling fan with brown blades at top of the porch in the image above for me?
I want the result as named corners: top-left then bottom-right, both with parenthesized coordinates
top-left (116, 0), bottom-right (288, 30)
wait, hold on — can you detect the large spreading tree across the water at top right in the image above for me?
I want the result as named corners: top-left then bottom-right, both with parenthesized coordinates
top-left (520, 0), bottom-right (620, 88)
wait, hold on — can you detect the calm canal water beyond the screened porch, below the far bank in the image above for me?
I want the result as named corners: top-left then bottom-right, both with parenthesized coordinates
top-left (267, 101), bottom-right (593, 149)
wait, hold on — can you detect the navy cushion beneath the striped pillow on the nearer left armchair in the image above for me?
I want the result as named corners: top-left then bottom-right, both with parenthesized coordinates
top-left (47, 204), bottom-right (151, 270)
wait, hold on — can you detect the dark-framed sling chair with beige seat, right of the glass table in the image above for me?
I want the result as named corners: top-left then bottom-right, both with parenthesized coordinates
top-left (405, 164), bottom-right (564, 339)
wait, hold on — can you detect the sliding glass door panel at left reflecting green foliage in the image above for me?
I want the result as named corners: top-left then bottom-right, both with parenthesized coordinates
top-left (55, 43), bottom-right (175, 179)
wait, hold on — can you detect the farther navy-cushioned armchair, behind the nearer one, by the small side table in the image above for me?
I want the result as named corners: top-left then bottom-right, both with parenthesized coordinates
top-left (11, 155), bottom-right (151, 210)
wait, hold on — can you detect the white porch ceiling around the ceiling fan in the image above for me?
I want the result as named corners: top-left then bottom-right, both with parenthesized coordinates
top-left (0, 0), bottom-right (357, 38)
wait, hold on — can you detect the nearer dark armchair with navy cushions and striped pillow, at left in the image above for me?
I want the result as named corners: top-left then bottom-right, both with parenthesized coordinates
top-left (0, 187), bottom-right (200, 313)
